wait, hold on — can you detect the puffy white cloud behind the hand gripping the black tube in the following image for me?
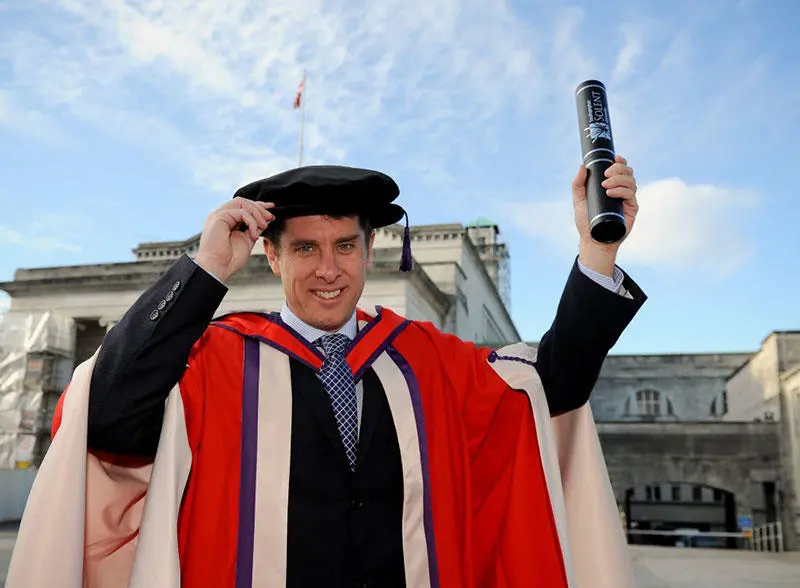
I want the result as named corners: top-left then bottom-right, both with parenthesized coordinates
top-left (504, 178), bottom-right (757, 276)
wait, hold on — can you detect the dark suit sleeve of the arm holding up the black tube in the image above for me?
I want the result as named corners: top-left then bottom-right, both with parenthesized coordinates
top-left (536, 260), bottom-right (647, 416)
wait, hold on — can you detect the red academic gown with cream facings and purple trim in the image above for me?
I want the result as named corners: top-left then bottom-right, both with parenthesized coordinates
top-left (3, 309), bottom-right (633, 588)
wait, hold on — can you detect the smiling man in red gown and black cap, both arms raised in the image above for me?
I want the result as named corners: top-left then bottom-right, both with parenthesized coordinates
top-left (9, 157), bottom-right (645, 588)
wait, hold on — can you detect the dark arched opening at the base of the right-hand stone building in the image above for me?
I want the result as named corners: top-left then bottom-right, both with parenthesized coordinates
top-left (625, 482), bottom-right (738, 549)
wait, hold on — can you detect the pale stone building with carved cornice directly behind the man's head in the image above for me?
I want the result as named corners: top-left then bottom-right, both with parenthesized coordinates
top-left (0, 221), bottom-right (519, 359)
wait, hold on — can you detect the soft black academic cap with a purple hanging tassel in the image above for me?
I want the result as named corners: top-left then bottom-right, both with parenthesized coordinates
top-left (233, 165), bottom-right (411, 271)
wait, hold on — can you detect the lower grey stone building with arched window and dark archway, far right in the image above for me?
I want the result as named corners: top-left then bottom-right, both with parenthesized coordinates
top-left (591, 332), bottom-right (800, 549)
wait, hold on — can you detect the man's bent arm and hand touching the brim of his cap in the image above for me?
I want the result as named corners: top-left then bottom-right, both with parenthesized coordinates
top-left (83, 198), bottom-right (273, 457)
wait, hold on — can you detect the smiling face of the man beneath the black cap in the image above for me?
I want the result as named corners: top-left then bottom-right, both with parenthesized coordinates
top-left (264, 216), bottom-right (374, 331)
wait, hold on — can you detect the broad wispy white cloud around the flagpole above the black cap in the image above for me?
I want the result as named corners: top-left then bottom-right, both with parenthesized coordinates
top-left (0, 0), bottom-right (542, 190)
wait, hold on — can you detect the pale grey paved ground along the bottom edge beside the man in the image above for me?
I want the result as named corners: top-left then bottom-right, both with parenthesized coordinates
top-left (0, 526), bottom-right (800, 588)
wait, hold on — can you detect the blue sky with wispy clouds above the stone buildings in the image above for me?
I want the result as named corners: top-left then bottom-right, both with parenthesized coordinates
top-left (0, 0), bottom-right (800, 353)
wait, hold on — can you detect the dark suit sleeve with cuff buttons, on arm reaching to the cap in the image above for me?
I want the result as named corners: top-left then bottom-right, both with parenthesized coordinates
top-left (88, 256), bottom-right (227, 457)
